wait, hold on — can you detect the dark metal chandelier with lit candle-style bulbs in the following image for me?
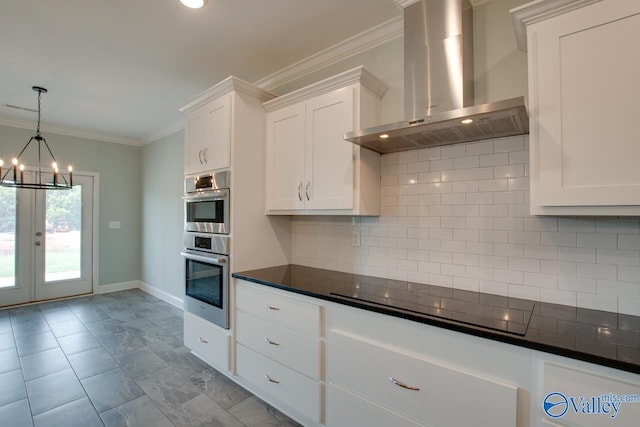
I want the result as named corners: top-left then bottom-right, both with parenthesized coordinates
top-left (0, 86), bottom-right (73, 190)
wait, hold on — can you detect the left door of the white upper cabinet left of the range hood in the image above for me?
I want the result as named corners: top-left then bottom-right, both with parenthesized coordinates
top-left (266, 103), bottom-right (305, 210)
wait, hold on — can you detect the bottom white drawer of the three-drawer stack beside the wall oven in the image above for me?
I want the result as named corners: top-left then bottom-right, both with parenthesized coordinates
top-left (236, 344), bottom-right (322, 422)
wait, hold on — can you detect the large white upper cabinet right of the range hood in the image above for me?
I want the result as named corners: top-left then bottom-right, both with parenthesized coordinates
top-left (512, 0), bottom-right (640, 215)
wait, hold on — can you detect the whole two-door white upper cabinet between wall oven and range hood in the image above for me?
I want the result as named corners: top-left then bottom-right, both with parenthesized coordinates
top-left (264, 67), bottom-right (386, 215)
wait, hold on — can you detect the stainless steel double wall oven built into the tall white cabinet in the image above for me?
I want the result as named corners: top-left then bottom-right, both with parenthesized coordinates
top-left (181, 172), bottom-right (231, 329)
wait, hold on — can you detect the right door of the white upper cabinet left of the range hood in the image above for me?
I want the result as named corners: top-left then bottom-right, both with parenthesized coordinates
top-left (304, 87), bottom-right (355, 209)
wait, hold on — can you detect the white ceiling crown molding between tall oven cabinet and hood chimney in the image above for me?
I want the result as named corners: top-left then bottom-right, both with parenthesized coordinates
top-left (255, 16), bottom-right (404, 91)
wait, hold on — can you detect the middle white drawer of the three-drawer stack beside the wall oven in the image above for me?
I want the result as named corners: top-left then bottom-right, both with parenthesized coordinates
top-left (236, 312), bottom-right (321, 380)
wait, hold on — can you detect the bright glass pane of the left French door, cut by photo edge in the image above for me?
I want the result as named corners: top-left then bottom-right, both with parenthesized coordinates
top-left (0, 187), bottom-right (17, 288)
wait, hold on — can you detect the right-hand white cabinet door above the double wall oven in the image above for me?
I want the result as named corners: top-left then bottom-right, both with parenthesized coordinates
top-left (202, 93), bottom-right (231, 171)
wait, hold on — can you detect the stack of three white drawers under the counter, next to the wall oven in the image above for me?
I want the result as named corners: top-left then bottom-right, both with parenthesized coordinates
top-left (236, 280), bottom-right (324, 426)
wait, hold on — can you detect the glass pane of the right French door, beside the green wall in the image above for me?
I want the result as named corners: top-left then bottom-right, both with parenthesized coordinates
top-left (44, 185), bottom-right (82, 282)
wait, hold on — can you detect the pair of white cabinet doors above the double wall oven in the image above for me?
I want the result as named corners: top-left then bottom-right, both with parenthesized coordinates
top-left (184, 94), bottom-right (231, 175)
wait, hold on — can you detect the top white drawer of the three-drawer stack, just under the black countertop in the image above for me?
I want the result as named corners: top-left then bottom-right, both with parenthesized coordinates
top-left (236, 281), bottom-right (320, 337)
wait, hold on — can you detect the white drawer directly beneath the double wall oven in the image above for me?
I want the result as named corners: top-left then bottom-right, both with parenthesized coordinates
top-left (184, 311), bottom-right (231, 371)
